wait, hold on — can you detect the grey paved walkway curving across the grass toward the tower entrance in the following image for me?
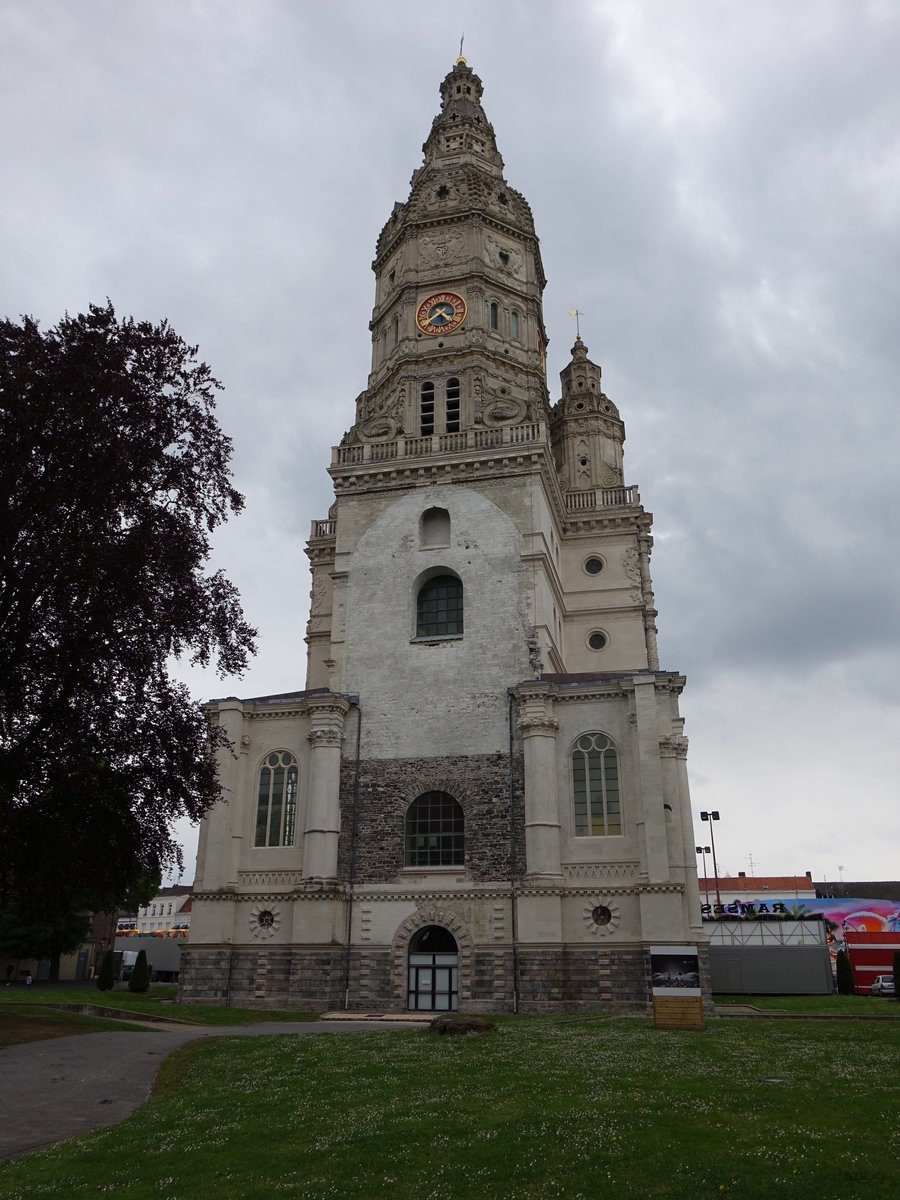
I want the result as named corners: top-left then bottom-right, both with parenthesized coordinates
top-left (0, 1014), bottom-right (415, 1159)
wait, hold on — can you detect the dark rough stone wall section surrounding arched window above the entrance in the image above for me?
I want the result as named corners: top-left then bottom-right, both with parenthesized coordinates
top-left (338, 754), bottom-right (524, 884)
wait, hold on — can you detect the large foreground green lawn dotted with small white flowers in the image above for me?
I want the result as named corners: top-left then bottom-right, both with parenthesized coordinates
top-left (0, 1018), bottom-right (900, 1200)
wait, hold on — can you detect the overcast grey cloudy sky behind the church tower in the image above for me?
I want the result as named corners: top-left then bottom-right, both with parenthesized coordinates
top-left (0, 0), bottom-right (900, 881)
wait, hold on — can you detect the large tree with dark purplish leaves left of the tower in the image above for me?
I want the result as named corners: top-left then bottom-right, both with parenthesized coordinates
top-left (0, 297), bottom-right (254, 945)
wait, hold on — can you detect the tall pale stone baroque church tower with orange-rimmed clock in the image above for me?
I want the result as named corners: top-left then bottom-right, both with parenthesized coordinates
top-left (181, 58), bottom-right (706, 1012)
